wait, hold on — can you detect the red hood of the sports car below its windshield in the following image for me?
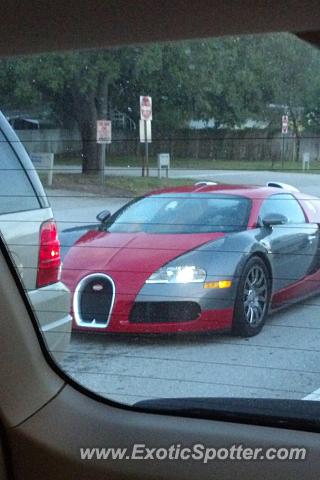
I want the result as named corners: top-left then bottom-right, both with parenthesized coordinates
top-left (64, 231), bottom-right (225, 275)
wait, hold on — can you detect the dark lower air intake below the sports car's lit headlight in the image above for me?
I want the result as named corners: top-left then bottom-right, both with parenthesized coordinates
top-left (130, 302), bottom-right (201, 323)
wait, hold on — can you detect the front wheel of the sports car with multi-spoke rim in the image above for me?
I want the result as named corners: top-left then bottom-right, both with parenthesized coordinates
top-left (232, 256), bottom-right (271, 337)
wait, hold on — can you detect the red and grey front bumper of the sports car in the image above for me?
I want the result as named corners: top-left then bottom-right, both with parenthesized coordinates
top-left (73, 283), bottom-right (235, 334)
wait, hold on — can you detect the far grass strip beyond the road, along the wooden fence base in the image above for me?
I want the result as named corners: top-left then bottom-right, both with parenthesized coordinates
top-left (55, 155), bottom-right (320, 173)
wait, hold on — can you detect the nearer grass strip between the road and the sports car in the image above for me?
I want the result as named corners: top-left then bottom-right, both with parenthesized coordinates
top-left (40, 173), bottom-right (194, 197)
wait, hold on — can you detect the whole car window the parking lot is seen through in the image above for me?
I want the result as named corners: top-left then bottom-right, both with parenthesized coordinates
top-left (0, 30), bottom-right (320, 414)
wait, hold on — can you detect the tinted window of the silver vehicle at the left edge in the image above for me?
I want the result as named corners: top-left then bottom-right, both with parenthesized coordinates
top-left (0, 132), bottom-right (40, 214)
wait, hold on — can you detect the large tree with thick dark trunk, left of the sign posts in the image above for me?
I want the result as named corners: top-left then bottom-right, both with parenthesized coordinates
top-left (30, 50), bottom-right (120, 173)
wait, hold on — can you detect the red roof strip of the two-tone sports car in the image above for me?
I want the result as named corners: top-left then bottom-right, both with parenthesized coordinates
top-left (148, 184), bottom-right (293, 199)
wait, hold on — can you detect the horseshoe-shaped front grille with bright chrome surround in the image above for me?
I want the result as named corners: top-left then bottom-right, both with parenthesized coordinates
top-left (74, 274), bottom-right (115, 328)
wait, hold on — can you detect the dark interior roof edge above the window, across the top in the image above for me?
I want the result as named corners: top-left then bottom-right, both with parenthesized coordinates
top-left (0, 0), bottom-right (320, 56)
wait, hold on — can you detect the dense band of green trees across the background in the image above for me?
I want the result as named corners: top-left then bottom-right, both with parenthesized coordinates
top-left (0, 34), bottom-right (320, 169)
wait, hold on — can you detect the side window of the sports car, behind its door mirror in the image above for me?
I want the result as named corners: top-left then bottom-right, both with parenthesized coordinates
top-left (259, 193), bottom-right (306, 223)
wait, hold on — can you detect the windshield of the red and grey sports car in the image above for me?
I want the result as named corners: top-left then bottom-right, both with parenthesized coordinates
top-left (105, 193), bottom-right (251, 234)
